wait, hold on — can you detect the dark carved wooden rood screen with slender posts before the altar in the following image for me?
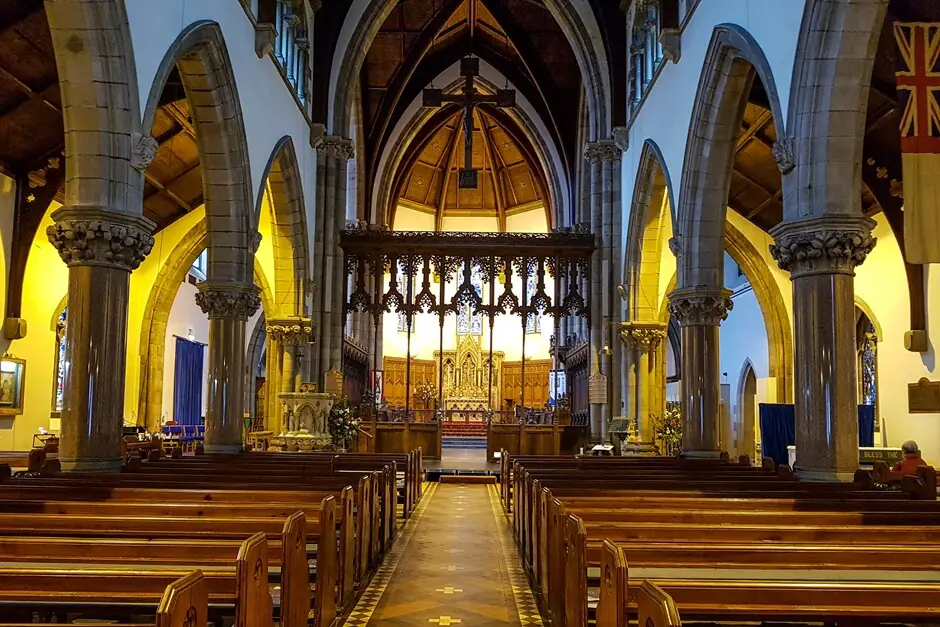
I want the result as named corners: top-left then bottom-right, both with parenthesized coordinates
top-left (340, 227), bottom-right (594, 417)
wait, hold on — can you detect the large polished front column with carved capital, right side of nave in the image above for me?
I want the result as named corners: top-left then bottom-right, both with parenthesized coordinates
top-left (770, 216), bottom-right (875, 481)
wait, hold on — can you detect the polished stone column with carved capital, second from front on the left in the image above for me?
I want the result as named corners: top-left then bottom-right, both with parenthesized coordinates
top-left (196, 281), bottom-right (260, 453)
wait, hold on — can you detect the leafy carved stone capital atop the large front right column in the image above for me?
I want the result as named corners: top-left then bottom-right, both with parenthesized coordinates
top-left (770, 216), bottom-right (877, 278)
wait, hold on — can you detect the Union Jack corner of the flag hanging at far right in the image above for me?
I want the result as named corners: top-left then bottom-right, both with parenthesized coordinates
top-left (894, 22), bottom-right (940, 153)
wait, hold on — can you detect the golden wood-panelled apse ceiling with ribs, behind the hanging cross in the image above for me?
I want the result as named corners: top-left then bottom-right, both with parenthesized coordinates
top-left (389, 106), bottom-right (552, 231)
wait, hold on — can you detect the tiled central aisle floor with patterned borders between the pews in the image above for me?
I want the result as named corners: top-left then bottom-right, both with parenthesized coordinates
top-left (345, 483), bottom-right (542, 627)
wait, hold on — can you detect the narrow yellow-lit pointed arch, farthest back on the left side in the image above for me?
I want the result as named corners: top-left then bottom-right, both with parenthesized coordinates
top-left (255, 136), bottom-right (310, 317)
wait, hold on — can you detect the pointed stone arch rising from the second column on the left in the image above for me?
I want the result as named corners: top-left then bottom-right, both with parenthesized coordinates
top-left (142, 21), bottom-right (257, 285)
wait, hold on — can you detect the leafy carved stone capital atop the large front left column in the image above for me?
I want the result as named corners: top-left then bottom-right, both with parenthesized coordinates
top-left (46, 207), bottom-right (156, 272)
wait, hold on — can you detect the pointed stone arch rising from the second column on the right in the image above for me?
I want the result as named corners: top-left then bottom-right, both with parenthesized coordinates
top-left (676, 24), bottom-right (784, 289)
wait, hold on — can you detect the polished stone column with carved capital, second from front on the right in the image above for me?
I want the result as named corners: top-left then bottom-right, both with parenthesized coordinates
top-left (669, 288), bottom-right (734, 458)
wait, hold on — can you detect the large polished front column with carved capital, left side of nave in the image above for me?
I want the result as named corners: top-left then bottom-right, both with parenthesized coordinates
top-left (46, 207), bottom-right (154, 472)
